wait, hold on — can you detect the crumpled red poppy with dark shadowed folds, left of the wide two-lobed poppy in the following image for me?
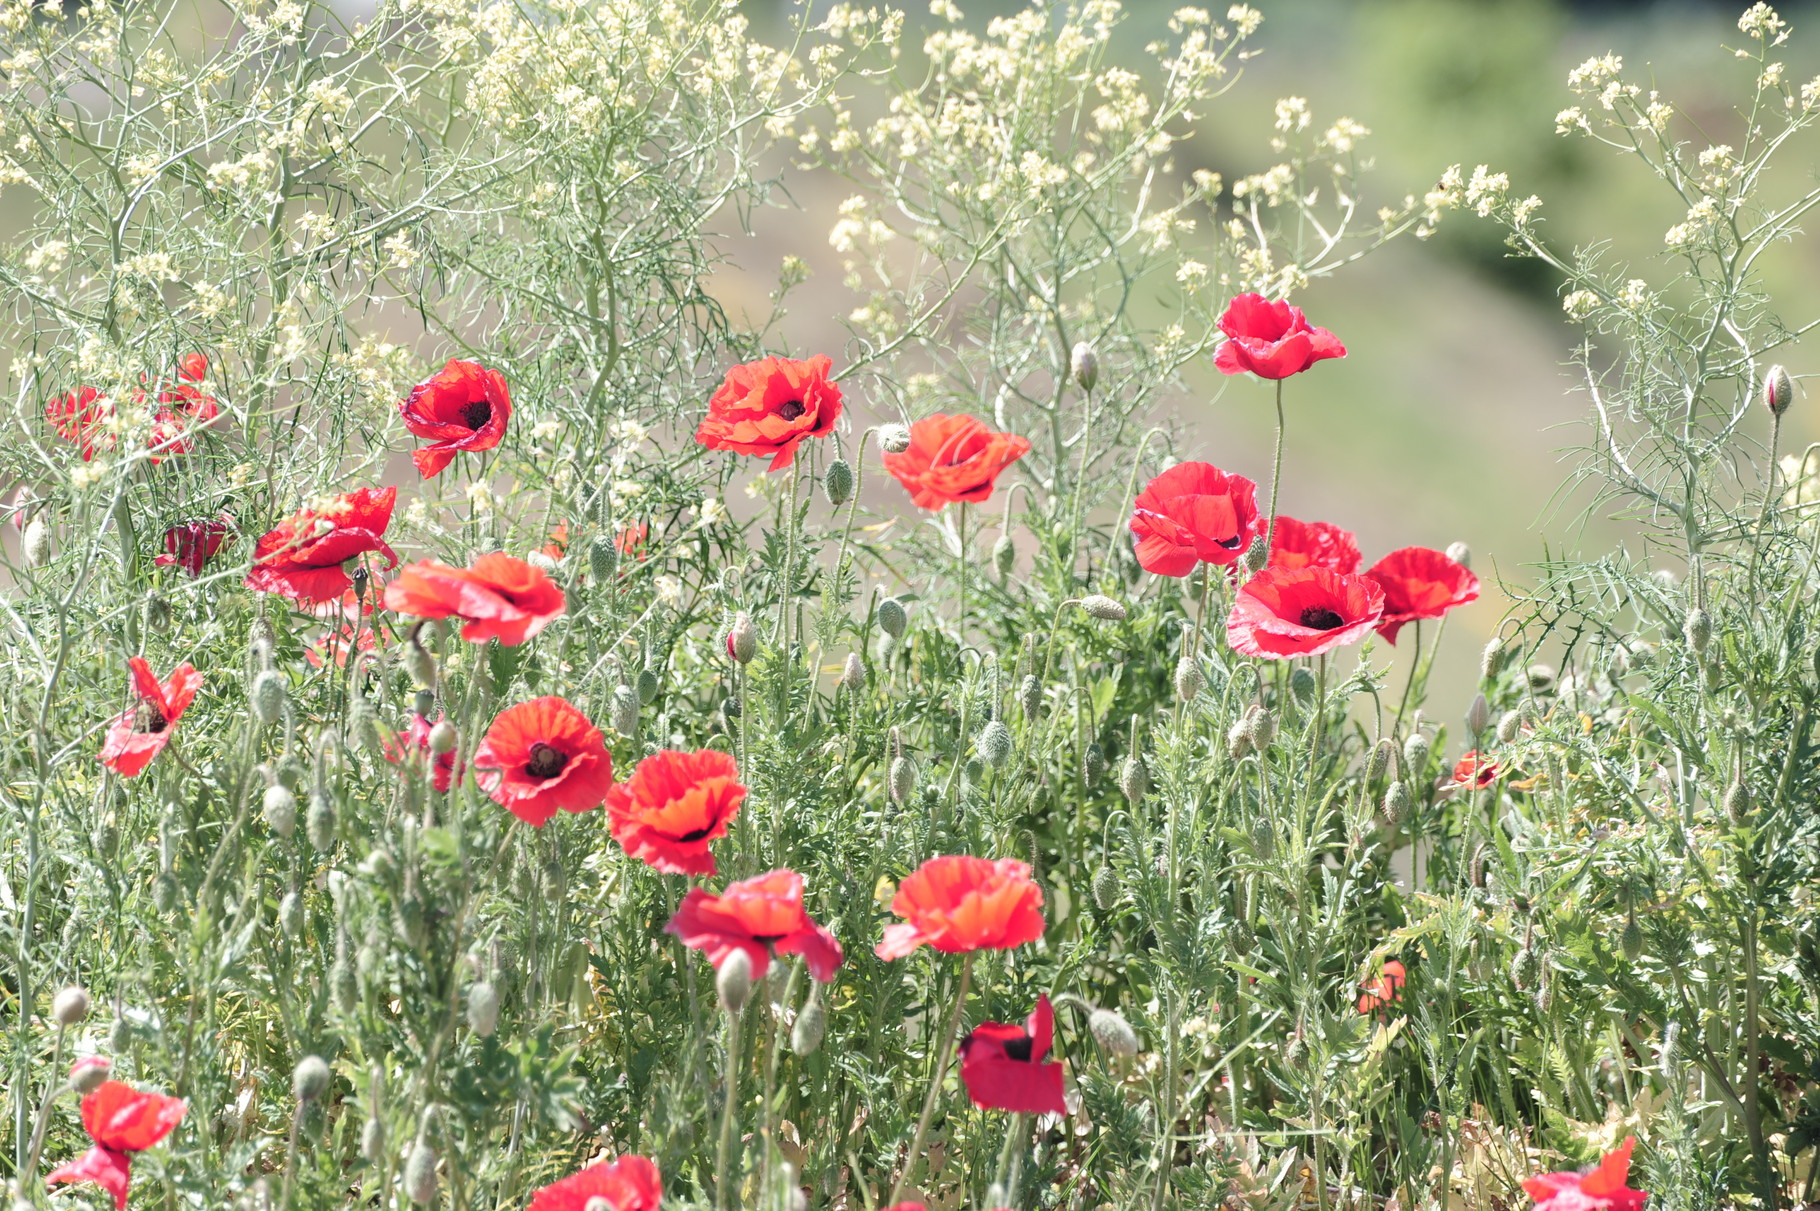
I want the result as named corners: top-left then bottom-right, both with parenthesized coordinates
top-left (246, 488), bottom-right (399, 606)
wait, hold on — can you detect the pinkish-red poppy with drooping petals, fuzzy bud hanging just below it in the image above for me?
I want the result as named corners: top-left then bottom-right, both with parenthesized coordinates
top-left (664, 870), bottom-right (841, 983)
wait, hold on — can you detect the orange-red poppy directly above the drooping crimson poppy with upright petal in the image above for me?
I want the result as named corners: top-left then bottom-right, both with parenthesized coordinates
top-left (875, 854), bottom-right (1043, 960)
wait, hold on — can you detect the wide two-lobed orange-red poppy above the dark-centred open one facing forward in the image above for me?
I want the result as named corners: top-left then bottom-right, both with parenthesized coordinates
top-left (386, 552), bottom-right (566, 646)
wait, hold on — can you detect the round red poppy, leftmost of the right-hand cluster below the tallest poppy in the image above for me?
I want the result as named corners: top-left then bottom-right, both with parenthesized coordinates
top-left (1130, 463), bottom-right (1261, 575)
